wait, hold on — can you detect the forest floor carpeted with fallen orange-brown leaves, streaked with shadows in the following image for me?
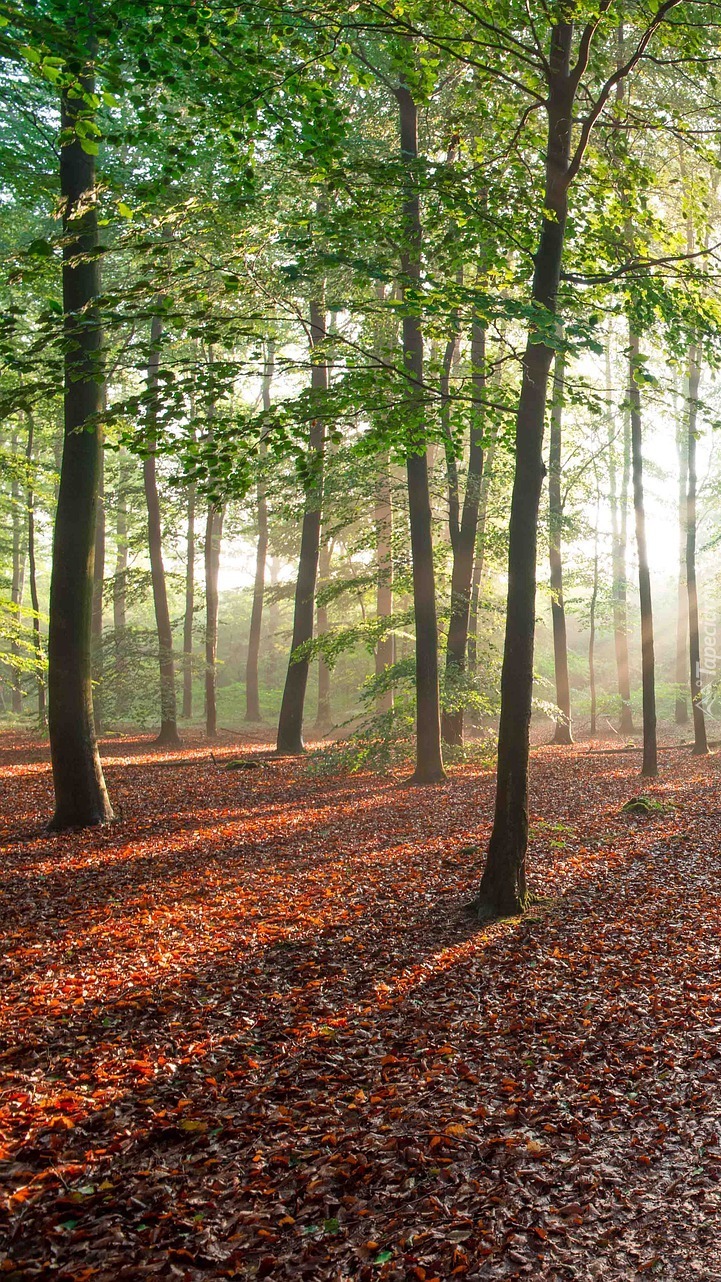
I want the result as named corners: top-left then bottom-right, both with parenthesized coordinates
top-left (0, 735), bottom-right (721, 1282)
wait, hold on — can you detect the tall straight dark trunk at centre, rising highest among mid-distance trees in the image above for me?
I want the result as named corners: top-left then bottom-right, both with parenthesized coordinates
top-left (396, 85), bottom-right (445, 783)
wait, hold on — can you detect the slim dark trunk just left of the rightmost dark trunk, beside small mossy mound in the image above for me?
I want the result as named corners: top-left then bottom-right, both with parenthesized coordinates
top-left (629, 322), bottom-right (658, 778)
